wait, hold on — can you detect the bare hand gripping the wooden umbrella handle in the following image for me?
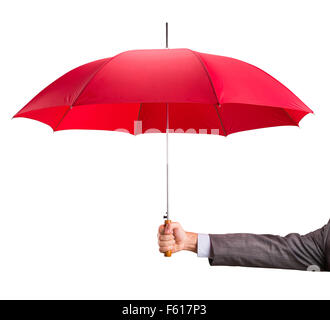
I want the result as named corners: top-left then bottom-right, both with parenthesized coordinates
top-left (158, 222), bottom-right (197, 253)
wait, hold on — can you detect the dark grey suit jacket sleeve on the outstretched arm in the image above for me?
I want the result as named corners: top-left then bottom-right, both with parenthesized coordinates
top-left (209, 221), bottom-right (330, 270)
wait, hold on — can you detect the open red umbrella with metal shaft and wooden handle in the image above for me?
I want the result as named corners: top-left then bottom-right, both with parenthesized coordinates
top-left (14, 23), bottom-right (312, 255)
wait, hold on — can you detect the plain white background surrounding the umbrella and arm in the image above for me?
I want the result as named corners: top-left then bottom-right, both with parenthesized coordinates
top-left (0, 0), bottom-right (330, 299)
